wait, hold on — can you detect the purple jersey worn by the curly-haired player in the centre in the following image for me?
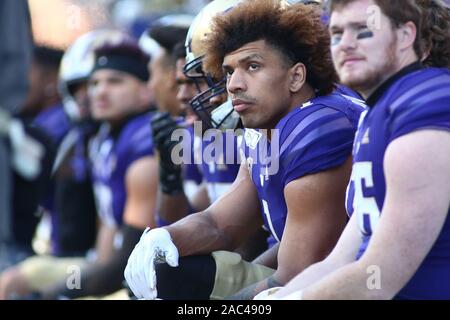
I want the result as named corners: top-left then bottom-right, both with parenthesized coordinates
top-left (245, 93), bottom-right (364, 245)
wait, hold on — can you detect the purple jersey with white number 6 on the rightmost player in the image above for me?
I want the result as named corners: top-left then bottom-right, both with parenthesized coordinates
top-left (347, 64), bottom-right (450, 299)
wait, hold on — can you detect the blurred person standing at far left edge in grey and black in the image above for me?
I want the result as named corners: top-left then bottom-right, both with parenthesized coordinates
top-left (0, 0), bottom-right (52, 271)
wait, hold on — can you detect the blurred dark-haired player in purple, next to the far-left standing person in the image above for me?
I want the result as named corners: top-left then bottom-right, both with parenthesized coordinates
top-left (0, 45), bottom-right (65, 272)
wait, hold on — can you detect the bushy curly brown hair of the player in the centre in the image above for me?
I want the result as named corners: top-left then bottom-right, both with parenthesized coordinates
top-left (204, 0), bottom-right (337, 95)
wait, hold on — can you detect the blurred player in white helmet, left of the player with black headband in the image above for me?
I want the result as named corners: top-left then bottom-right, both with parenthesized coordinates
top-left (0, 32), bottom-right (110, 299)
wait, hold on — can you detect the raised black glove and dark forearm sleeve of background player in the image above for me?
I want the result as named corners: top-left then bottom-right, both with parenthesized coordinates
top-left (151, 112), bottom-right (183, 195)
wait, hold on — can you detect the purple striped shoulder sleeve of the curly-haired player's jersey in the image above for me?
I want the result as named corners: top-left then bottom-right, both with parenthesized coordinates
top-left (277, 93), bottom-right (365, 186)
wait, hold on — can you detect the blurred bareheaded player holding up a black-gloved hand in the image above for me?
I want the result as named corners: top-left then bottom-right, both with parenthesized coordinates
top-left (139, 15), bottom-right (207, 225)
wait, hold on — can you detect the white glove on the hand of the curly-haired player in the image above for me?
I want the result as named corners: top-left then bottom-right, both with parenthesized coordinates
top-left (124, 228), bottom-right (178, 300)
